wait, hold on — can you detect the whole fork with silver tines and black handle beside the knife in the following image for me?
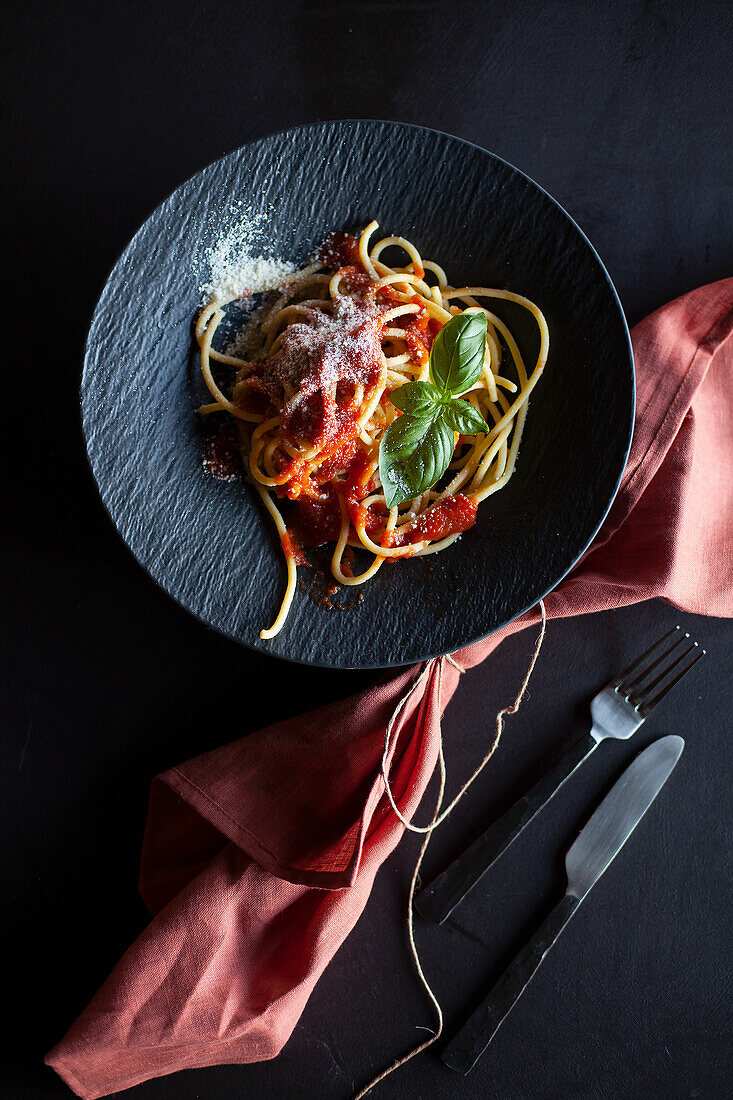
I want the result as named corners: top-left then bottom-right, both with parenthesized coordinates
top-left (415, 626), bottom-right (705, 924)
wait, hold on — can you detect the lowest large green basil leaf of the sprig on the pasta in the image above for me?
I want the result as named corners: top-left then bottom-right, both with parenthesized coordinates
top-left (380, 414), bottom-right (456, 508)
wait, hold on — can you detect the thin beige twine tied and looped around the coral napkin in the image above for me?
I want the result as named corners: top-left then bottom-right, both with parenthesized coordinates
top-left (352, 600), bottom-right (547, 1100)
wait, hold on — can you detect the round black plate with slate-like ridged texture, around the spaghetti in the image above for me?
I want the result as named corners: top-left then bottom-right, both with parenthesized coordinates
top-left (81, 121), bottom-right (634, 668)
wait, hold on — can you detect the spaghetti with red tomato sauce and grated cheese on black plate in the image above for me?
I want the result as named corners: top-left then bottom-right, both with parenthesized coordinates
top-left (196, 221), bottom-right (549, 638)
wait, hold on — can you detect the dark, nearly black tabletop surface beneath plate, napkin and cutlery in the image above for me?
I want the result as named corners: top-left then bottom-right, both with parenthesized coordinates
top-left (0, 0), bottom-right (733, 1100)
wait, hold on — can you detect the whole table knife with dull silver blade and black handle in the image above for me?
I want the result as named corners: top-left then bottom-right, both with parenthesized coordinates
top-left (440, 736), bottom-right (685, 1074)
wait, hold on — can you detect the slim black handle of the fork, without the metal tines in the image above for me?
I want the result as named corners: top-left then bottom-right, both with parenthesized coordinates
top-left (415, 734), bottom-right (598, 924)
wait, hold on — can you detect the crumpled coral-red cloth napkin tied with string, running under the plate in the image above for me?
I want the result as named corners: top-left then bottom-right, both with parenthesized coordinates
top-left (46, 278), bottom-right (733, 1098)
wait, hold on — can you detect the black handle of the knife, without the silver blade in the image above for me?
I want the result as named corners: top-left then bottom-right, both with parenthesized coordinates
top-left (440, 894), bottom-right (580, 1074)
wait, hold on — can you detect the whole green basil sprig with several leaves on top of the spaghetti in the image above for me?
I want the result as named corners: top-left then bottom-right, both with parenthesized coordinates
top-left (380, 314), bottom-right (489, 508)
